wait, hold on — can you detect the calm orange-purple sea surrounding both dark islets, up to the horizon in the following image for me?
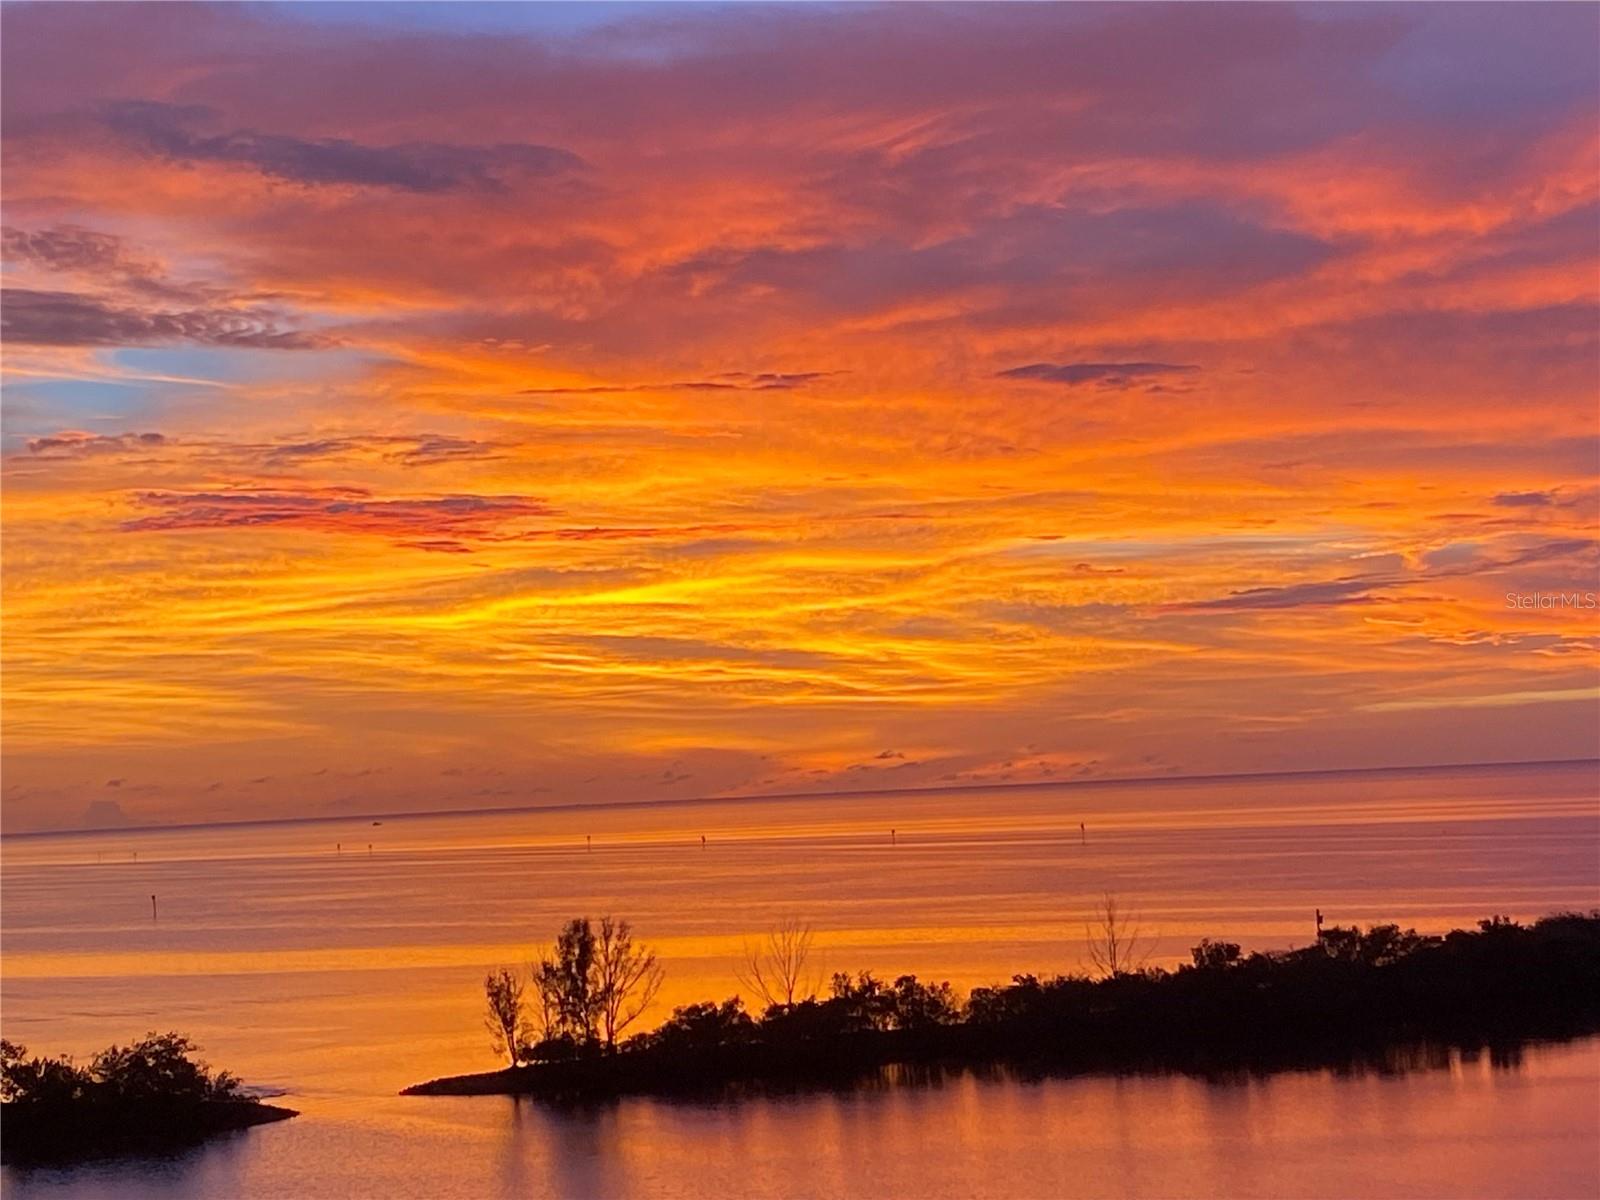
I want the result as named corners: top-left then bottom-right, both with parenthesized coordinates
top-left (0, 763), bottom-right (1600, 1197)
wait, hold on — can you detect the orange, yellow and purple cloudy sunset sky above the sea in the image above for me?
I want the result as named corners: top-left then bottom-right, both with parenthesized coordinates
top-left (3, 3), bottom-right (1600, 832)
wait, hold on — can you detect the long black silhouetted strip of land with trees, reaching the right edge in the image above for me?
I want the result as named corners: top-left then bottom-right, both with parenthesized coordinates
top-left (408, 898), bottom-right (1600, 1098)
